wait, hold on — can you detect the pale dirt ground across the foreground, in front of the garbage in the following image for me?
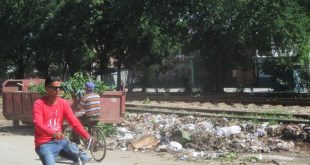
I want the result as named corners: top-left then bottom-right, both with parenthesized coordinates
top-left (0, 118), bottom-right (310, 165)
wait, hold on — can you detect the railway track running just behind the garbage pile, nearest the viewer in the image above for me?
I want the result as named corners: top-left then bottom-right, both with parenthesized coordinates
top-left (126, 103), bottom-right (310, 124)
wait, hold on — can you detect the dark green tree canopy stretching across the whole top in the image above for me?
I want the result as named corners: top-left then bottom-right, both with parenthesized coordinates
top-left (0, 0), bottom-right (310, 91)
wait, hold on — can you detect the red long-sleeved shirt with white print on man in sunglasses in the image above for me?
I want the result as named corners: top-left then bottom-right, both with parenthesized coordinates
top-left (33, 97), bottom-right (90, 148)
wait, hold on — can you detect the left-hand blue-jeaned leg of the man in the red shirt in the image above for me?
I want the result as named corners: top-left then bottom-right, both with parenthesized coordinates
top-left (36, 140), bottom-right (61, 165)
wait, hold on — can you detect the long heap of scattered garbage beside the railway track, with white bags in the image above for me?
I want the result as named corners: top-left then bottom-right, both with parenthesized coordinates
top-left (108, 113), bottom-right (310, 160)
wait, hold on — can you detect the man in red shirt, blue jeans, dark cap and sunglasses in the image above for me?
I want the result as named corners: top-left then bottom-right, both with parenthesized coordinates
top-left (33, 77), bottom-right (92, 165)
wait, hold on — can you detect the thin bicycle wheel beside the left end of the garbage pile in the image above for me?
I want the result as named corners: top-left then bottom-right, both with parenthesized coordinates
top-left (90, 128), bottom-right (107, 162)
